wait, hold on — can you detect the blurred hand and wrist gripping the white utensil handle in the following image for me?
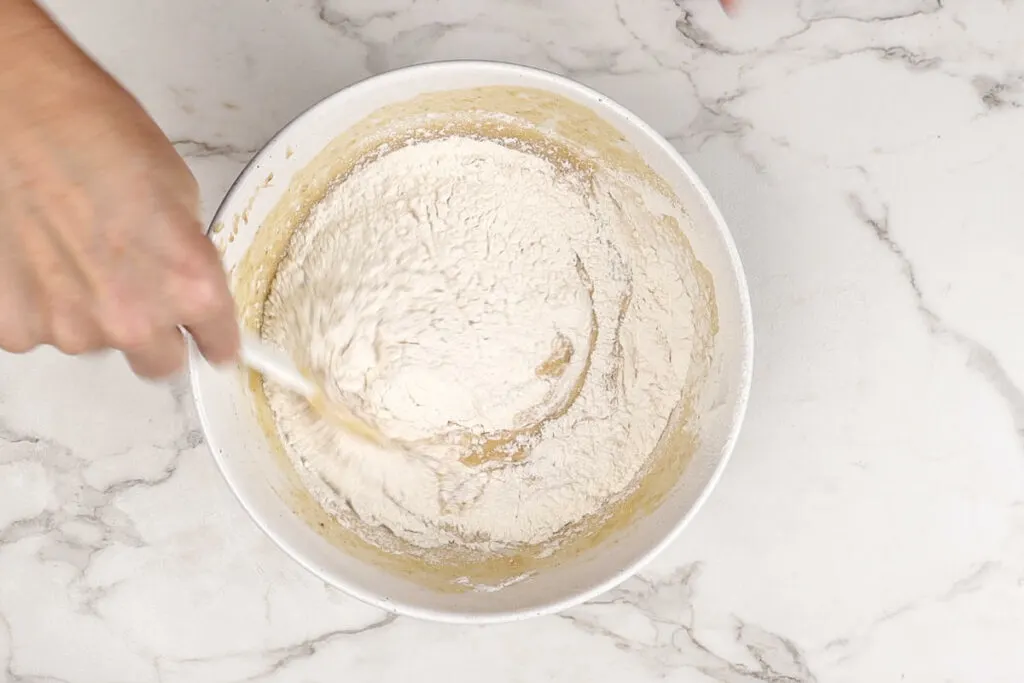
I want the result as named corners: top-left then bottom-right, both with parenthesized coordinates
top-left (0, 0), bottom-right (239, 378)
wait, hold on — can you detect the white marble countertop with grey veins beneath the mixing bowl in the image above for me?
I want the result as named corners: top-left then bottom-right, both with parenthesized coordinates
top-left (0, 0), bottom-right (1024, 683)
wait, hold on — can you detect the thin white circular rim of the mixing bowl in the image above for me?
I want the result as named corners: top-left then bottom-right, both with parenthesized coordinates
top-left (188, 59), bottom-right (754, 625)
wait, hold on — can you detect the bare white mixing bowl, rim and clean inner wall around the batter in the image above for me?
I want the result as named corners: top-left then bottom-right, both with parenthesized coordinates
top-left (191, 61), bottom-right (753, 623)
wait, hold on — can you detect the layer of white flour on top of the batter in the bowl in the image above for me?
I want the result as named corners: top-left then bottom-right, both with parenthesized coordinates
top-left (263, 137), bottom-right (692, 551)
